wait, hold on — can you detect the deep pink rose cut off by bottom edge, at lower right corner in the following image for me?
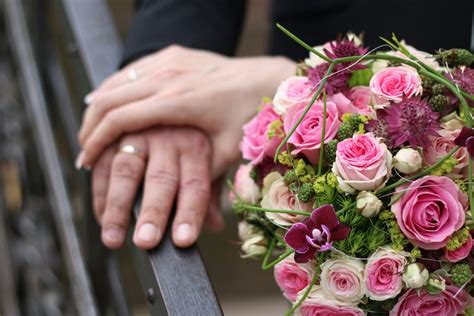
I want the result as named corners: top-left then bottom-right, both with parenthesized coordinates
top-left (390, 285), bottom-right (471, 316)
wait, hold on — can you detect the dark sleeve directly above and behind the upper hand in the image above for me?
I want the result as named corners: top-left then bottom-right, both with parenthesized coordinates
top-left (122, 0), bottom-right (245, 65)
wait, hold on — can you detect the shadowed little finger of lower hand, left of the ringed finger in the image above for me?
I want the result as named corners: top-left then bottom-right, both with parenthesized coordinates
top-left (92, 145), bottom-right (117, 224)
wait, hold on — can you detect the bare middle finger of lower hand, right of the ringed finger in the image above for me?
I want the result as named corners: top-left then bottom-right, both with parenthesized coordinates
top-left (133, 132), bottom-right (179, 249)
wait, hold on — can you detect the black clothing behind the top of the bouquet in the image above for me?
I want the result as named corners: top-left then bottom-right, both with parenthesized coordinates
top-left (271, 0), bottom-right (474, 60)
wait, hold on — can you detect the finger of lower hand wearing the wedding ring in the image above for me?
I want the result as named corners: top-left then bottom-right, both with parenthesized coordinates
top-left (102, 136), bottom-right (147, 248)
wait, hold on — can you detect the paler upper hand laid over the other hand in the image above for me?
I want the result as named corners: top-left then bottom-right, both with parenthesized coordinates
top-left (78, 46), bottom-right (294, 174)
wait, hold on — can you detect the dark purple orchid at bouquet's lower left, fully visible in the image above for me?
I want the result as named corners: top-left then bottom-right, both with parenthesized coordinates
top-left (285, 204), bottom-right (351, 263)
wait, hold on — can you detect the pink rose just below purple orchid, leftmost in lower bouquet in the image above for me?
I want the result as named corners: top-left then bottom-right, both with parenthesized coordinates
top-left (274, 256), bottom-right (314, 303)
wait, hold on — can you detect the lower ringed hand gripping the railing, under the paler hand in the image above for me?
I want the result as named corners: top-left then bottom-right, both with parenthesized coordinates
top-left (92, 127), bottom-right (223, 249)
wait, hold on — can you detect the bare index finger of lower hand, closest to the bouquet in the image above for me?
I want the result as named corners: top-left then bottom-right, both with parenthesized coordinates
top-left (173, 134), bottom-right (211, 247)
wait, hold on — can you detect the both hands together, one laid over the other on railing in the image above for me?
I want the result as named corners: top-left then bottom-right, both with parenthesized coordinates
top-left (76, 46), bottom-right (295, 249)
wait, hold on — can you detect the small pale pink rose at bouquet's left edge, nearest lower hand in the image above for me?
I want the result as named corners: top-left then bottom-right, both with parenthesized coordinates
top-left (229, 164), bottom-right (261, 204)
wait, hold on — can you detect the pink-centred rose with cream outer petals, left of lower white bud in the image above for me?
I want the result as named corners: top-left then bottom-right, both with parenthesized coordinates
top-left (365, 247), bottom-right (409, 301)
